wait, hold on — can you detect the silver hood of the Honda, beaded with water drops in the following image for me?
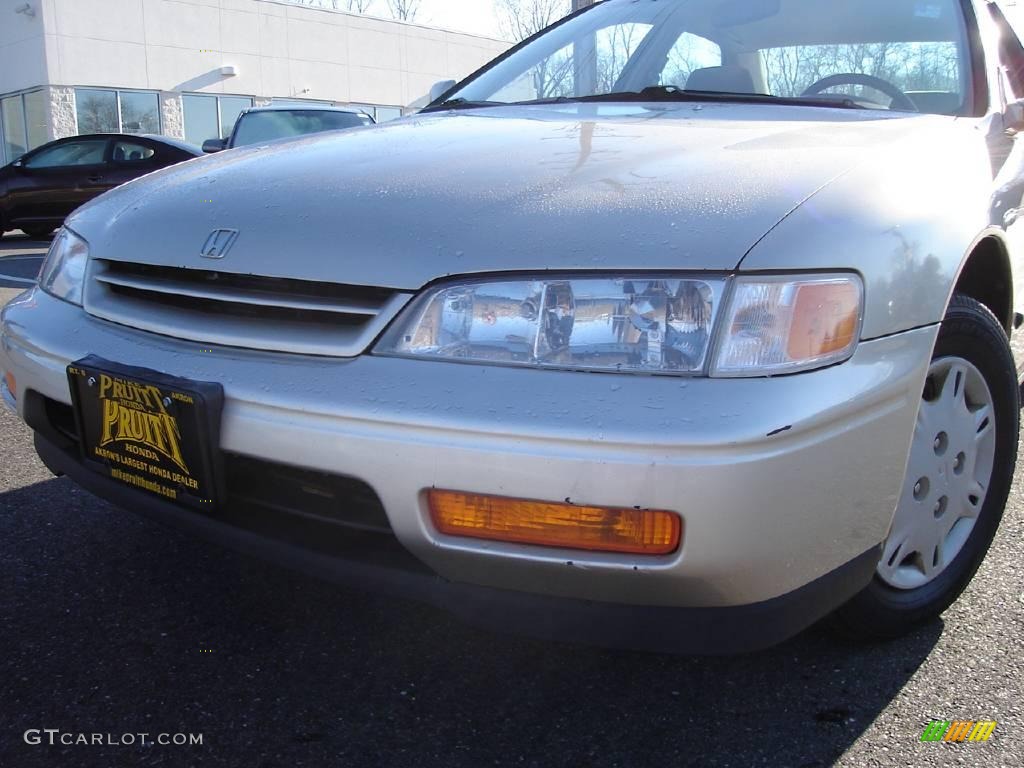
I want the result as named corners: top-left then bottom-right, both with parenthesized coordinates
top-left (69, 104), bottom-right (937, 290)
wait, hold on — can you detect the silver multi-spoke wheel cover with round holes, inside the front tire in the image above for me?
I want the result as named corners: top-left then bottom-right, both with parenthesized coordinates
top-left (878, 357), bottom-right (996, 590)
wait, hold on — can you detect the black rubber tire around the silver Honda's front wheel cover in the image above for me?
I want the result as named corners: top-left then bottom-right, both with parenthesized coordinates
top-left (830, 294), bottom-right (1020, 639)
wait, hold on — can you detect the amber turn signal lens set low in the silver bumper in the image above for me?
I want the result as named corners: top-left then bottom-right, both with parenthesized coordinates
top-left (428, 490), bottom-right (683, 555)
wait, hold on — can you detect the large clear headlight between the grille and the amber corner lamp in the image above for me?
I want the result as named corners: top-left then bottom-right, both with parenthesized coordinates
top-left (376, 276), bottom-right (725, 373)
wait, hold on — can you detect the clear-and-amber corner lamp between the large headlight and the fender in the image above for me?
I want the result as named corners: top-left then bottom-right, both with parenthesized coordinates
top-left (711, 274), bottom-right (864, 377)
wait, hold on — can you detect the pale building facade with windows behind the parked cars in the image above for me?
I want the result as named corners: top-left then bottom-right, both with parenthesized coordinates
top-left (0, 0), bottom-right (510, 165)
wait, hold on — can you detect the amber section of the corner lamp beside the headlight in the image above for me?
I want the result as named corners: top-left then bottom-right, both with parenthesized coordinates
top-left (786, 282), bottom-right (860, 359)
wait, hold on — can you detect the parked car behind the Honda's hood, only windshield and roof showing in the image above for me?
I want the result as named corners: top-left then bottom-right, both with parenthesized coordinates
top-left (203, 104), bottom-right (374, 153)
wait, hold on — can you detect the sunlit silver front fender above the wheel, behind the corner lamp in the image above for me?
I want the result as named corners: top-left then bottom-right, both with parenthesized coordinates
top-left (739, 117), bottom-right (1002, 339)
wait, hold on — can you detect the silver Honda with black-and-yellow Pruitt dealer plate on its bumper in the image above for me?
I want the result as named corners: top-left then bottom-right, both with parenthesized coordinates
top-left (0, 0), bottom-right (1024, 652)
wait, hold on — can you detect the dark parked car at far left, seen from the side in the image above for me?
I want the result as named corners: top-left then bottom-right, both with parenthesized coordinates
top-left (0, 133), bottom-right (203, 238)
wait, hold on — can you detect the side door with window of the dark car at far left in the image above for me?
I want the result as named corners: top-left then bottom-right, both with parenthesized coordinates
top-left (7, 137), bottom-right (111, 226)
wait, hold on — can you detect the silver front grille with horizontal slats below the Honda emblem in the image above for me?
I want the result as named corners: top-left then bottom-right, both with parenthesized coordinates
top-left (85, 259), bottom-right (412, 357)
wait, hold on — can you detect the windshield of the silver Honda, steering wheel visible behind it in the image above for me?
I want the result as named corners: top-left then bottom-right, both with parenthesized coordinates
top-left (444, 0), bottom-right (971, 115)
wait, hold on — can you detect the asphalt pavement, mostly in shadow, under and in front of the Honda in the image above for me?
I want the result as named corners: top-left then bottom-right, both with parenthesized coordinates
top-left (0, 282), bottom-right (1024, 768)
